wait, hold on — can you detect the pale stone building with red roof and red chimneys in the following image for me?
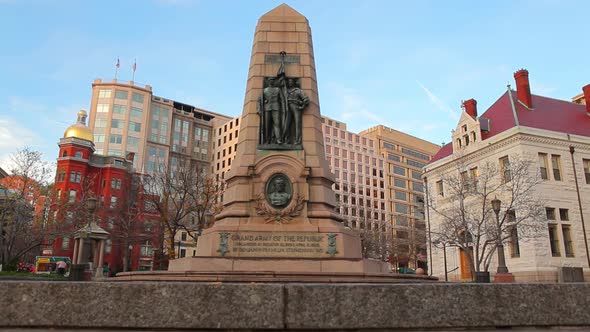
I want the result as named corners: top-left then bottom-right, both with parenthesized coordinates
top-left (424, 69), bottom-right (590, 281)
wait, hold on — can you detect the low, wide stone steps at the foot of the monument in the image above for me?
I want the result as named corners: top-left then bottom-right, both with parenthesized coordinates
top-left (110, 257), bottom-right (438, 283)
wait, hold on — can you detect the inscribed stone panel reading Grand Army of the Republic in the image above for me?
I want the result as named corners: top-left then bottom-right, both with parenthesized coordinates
top-left (228, 232), bottom-right (334, 258)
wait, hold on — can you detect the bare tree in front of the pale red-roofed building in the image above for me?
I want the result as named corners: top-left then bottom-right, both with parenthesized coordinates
top-left (428, 155), bottom-right (545, 276)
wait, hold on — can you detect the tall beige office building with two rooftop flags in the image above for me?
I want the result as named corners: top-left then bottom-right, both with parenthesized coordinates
top-left (89, 79), bottom-right (231, 173)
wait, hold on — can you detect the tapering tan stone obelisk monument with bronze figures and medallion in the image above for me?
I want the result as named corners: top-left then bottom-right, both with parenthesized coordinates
top-left (170, 4), bottom-right (386, 273)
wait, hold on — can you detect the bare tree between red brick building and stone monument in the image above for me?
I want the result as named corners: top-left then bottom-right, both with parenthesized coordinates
top-left (142, 157), bottom-right (224, 259)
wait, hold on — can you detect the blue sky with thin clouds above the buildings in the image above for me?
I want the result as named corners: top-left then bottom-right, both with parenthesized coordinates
top-left (0, 0), bottom-right (590, 169)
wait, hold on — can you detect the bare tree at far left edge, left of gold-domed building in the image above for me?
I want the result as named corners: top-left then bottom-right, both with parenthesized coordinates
top-left (0, 147), bottom-right (52, 265)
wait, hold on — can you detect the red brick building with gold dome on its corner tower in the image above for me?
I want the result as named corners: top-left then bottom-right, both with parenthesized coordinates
top-left (46, 111), bottom-right (159, 272)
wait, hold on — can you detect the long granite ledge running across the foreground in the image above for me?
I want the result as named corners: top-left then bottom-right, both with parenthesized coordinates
top-left (0, 281), bottom-right (590, 331)
